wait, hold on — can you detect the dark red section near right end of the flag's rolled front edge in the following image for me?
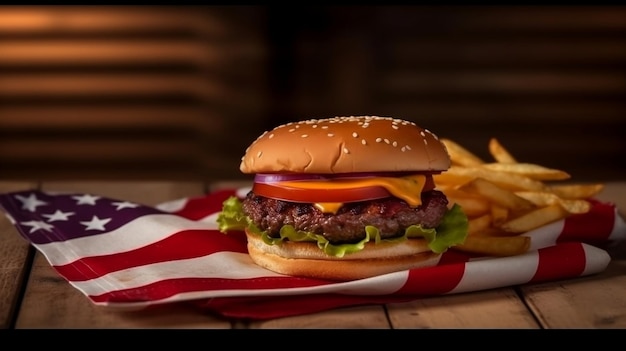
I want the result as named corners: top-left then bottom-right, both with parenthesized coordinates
top-left (530, 243), bottom-right (587, 283)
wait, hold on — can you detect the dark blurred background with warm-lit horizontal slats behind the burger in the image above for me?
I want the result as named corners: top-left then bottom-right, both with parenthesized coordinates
top-left (0, 6), bottom-right (626, 181)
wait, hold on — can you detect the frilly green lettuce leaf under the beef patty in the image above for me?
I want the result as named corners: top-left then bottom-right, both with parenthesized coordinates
top-left (217, 196), bottom-right (468, 257)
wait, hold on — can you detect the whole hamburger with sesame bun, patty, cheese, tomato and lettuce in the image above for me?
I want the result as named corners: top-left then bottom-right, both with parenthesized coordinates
top-left (217, 116), bottom-right (468, 281)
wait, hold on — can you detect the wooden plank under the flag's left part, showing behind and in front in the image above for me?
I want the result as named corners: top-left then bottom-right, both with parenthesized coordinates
top-left (16, 181), bottom-right (231, 329)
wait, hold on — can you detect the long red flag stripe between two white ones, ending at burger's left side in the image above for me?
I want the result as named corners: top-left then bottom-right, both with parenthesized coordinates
top-left (54, 230), bottom-right (248, 281)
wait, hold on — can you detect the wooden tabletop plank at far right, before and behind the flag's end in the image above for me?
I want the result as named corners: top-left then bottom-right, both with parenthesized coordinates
top-left (521, 182), bottom-right (626, 329)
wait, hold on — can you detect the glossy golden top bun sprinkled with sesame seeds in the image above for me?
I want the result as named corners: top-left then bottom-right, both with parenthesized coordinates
top-left (239, 116), bottom-right (450, 174)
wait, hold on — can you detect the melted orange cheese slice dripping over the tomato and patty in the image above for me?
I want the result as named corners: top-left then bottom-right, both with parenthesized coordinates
top-left (281, 174), bottom-right (426, 213)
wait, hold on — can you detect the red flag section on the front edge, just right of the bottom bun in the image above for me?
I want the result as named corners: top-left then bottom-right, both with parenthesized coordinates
top-left (395, 263), bottom-right (465, 295)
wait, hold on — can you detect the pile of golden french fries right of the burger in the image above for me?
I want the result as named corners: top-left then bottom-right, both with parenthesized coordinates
top-left (435, 138), bottom-right (604, 256)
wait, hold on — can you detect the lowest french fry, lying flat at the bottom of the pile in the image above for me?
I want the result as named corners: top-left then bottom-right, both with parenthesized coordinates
top-left (453, 235), bottom-right (530, 256)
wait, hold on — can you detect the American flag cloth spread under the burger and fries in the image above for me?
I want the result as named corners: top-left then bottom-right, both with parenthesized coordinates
top-left (0, 188), bottom-right (626, 319)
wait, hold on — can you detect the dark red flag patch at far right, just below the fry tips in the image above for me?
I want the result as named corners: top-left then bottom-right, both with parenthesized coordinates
top-left (557, 200), bottom-right (615, 246)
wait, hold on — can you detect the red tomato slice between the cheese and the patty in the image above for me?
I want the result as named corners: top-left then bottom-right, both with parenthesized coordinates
top-left (252, 183), bottom-right (391, 202)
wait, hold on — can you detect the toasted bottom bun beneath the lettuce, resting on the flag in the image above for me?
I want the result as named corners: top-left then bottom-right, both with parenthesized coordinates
top-left (246, 231), bottom-right (441, 281)
